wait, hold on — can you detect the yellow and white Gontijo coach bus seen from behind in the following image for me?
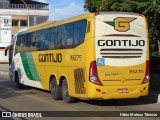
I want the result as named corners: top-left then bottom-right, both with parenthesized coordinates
top-left (5, 12), bottom-right (150, 103)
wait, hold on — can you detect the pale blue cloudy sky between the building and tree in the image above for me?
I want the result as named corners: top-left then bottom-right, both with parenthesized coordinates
top-left (34, 0), bottom-right (88, 20)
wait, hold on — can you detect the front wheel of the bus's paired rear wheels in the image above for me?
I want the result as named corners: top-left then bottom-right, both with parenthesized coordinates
top-left (50, 78), bottom-right (62, 100)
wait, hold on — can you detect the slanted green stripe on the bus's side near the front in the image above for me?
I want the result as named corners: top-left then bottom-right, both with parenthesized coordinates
top-left (21, 52), bottom-right (41, 81)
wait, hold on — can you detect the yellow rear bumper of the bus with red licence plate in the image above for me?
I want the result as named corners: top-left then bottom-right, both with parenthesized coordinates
top-left (88, 83), bottom-right (149, 100)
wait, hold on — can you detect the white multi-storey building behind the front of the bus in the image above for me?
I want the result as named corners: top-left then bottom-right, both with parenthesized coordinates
top-left (0, 0), bottom-right (49, 64)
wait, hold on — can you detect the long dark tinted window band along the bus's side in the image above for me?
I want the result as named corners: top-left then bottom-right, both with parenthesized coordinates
top-left (17, 20), bottom-right (87, 51)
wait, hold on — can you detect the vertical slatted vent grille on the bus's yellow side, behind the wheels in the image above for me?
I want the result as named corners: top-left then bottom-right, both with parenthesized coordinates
top-left (74, 68), bottom-right (86, 94)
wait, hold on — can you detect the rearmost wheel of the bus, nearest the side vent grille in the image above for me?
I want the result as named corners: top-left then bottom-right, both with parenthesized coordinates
top-left (62, 79), bottom-right (75, 103)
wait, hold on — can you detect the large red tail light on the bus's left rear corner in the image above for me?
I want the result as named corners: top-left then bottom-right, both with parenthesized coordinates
top-left (89, 61), bottom-right (102, 85)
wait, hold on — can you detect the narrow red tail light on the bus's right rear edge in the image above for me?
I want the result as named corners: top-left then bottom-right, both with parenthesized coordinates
top-left (142, 61), bottom-right (150, 84)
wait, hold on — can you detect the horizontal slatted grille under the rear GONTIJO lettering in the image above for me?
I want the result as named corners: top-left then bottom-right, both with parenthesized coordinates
top-left (100, 49), bottom-right (143, 58)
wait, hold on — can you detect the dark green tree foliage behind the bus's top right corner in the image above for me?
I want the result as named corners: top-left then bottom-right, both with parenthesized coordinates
top-left (84, 0), bottom-right (160, 56)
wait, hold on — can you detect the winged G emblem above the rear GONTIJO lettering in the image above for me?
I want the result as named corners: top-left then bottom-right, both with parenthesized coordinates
top-left (105, 17), bottom-right (136, 32)
